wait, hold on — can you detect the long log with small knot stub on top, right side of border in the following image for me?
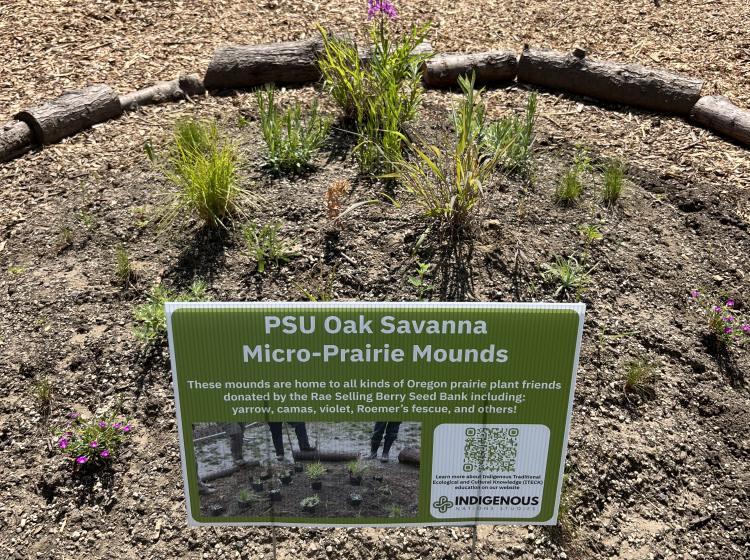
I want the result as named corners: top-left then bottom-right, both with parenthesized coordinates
top-left (518, 47), bottom-right (703, 116)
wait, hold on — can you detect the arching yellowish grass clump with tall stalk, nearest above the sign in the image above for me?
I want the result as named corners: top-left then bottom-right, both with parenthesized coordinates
top-left (384, 73), bottom-right (504, 236)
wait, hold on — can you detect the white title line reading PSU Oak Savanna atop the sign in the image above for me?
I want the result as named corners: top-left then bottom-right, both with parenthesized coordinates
top-left (265, 315), bottom-right (487, 334)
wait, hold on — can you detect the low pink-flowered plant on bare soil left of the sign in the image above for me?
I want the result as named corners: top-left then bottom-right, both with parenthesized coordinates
top-left (52, 402), bottom-right (132, 470)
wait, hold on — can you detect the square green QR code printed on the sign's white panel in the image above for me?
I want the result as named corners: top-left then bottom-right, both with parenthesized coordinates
top-left (464, 428), bottom-right (518, 472)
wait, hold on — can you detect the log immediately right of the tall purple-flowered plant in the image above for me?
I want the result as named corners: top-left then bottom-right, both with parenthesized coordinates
top-left (424, 51), bottom-right (518, 87)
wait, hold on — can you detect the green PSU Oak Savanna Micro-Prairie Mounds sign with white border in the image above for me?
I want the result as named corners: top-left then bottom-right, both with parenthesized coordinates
top-left (166, 303), bottom-right (585, 526)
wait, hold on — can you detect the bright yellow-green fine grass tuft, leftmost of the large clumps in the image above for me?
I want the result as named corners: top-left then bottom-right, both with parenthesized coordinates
top-left (147, 119), bottom-right (256, 231)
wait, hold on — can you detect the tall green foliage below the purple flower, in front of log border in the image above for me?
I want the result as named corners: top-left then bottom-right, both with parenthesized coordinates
top-left (318, 24), bottom-right (431, 173)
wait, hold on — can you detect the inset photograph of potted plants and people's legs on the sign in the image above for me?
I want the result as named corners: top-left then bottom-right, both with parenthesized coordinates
top-left (192, 421), bottom-right (422, 523)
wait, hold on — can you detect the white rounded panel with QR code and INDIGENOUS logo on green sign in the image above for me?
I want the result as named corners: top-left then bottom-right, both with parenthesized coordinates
top-left (430, 424), bottom-right (550, 519)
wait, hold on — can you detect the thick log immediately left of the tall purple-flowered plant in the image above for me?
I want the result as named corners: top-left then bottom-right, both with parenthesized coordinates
top-left (203, 37), bottom-right (323, 89)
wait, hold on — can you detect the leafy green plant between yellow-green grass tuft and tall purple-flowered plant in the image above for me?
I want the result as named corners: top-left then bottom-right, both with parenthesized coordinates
top-left (255, 84), bottom-right (331, 172)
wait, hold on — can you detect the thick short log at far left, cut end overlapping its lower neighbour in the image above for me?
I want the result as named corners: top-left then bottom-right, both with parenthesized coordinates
top-left (15, 84), bottom-right (122, 144)
